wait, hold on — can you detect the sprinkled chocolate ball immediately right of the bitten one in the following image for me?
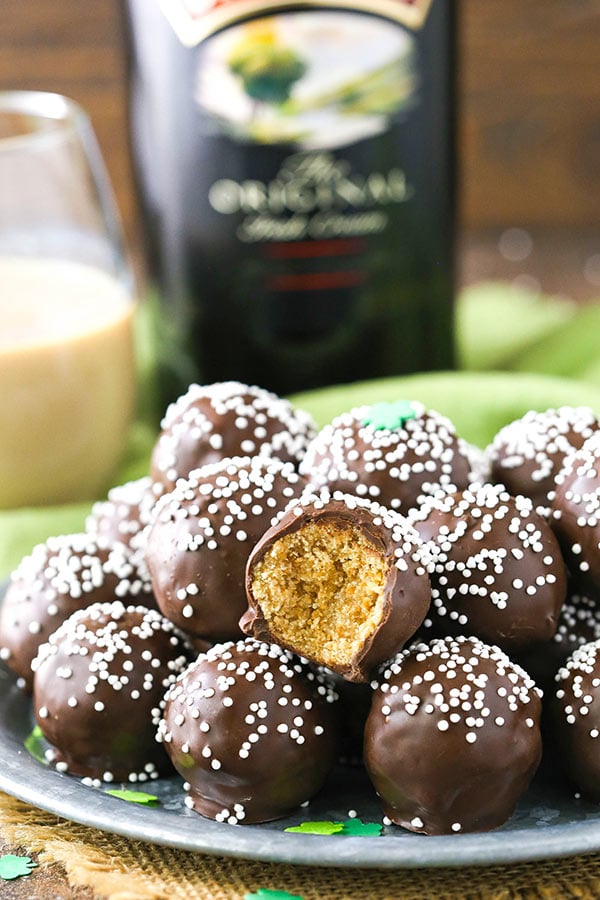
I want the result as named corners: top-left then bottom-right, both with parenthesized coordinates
top-left (414, 484), bottom-right (567, 650)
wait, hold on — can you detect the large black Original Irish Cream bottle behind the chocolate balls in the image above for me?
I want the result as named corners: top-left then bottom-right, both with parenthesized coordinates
top-left (125, 0), bottom-right (456, 401)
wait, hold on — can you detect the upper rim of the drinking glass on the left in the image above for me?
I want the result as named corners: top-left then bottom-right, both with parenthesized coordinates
top-left (0, 90), bottom-right (90, 151)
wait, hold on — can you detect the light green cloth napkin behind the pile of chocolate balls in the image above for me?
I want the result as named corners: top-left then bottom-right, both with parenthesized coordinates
top-left (0, 283), bottom-right (600, 579)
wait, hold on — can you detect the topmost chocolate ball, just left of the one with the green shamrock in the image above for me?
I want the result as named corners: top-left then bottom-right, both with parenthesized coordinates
top-left (150, 381), bottom-right (316, 490)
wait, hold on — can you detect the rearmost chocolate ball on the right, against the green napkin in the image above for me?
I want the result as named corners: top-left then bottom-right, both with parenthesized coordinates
top-left (486, 406), bottom-right (600, 510)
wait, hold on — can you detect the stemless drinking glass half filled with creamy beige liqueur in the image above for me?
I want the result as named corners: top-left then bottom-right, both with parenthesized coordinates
top-left (0, 91), bottom-right (136, 508)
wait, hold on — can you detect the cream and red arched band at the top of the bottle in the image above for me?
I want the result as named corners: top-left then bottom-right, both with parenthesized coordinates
top-left (159, 0), bottom-right (433, 47)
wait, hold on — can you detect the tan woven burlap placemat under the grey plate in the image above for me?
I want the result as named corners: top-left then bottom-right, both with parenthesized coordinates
top-left (0, 794), bottom-right (600, 900)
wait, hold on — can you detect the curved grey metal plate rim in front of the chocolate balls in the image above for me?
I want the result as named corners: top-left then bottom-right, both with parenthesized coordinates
top-left (0, 581), bottom-right (600, 869)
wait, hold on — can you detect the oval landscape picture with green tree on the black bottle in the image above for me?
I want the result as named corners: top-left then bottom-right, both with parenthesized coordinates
top-left (195, 10), bottom-right (418, 149)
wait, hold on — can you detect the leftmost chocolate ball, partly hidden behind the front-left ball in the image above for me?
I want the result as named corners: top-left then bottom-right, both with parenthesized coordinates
top-left (0, 534), bottom-right (154, 691)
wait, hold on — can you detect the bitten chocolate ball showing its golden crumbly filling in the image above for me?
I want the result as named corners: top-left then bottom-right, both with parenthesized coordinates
top-left (240, 492), bottom-right (431, 682)
